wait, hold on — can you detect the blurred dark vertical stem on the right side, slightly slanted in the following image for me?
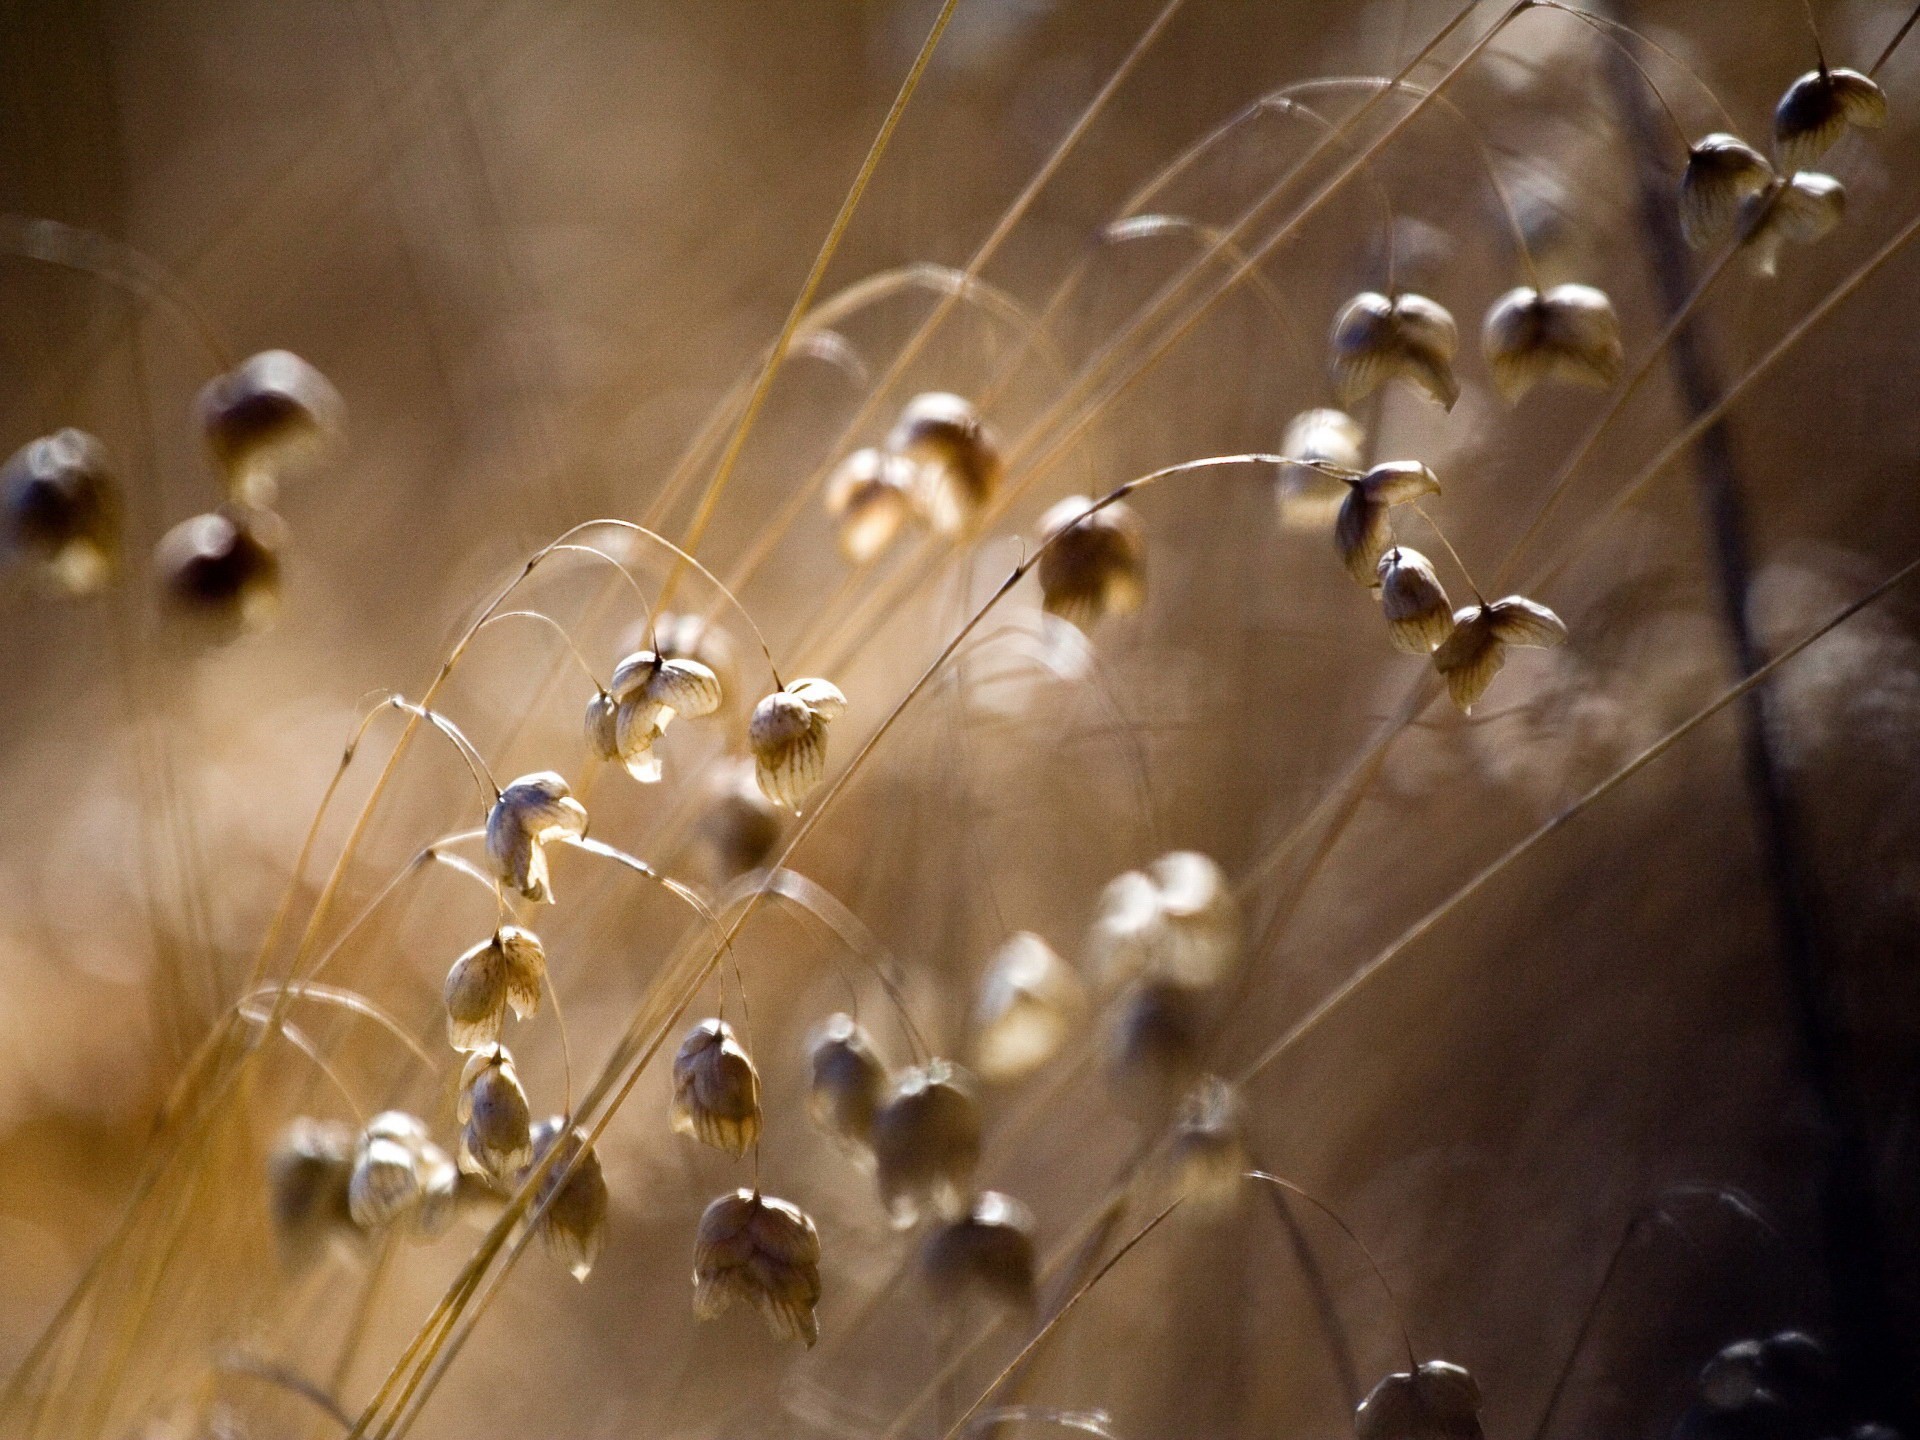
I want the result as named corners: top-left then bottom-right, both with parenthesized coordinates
top-left (1609, 4), bottom-right (1914, 1425)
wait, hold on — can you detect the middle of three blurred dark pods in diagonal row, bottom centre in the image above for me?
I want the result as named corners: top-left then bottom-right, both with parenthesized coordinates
top-left (872, 1060), bottom-right (981, 1231)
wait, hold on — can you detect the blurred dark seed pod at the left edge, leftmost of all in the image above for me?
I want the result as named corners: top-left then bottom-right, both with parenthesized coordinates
top-left (0, 430), bottom-right (121, 595)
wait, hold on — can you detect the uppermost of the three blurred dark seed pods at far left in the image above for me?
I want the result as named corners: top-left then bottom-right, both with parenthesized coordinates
top-left (194, 349), bottom-right (346, 505)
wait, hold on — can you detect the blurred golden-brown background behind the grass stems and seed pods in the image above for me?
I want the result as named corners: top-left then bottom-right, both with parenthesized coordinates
top-left (0, 0), bottom-right (1920, 1440)
